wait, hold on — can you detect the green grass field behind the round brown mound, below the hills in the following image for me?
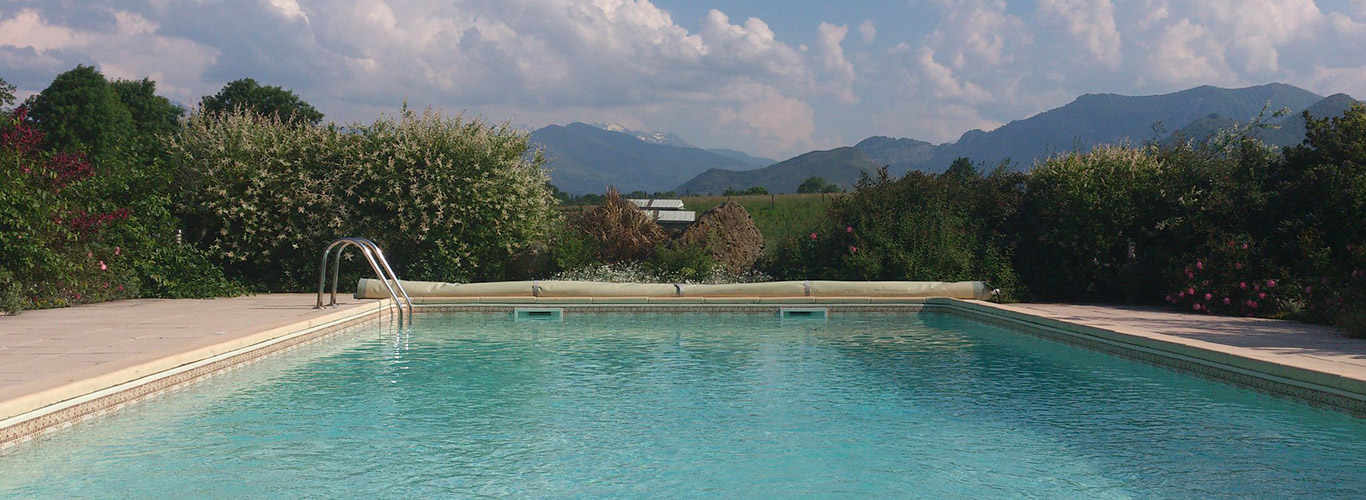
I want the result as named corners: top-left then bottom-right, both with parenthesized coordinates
top-left (683, 194), bottom-right (843, 249)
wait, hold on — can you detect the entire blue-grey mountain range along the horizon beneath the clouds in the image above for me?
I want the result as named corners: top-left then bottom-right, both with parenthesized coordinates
top-left (531, 83), bottom-right (1356, 194)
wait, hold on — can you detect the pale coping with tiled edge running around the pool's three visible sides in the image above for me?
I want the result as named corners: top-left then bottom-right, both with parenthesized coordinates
top-left (0, 296), bottom-right (1366, 449)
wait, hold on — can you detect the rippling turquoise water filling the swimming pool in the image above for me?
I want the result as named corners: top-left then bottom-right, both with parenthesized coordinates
top-left (0, 314), bottom-right (1366, 499)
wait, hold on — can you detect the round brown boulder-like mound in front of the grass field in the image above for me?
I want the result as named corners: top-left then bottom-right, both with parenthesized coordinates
top-left (676, 201), bottom-right (764, 273)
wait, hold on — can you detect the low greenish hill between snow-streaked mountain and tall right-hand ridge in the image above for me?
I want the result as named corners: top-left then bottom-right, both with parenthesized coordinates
top-left (675, 148), bottom-right (880, 194)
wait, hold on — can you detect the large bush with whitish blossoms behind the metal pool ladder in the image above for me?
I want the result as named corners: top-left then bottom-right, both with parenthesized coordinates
top-left (169, 109), bottom-right (556, 291)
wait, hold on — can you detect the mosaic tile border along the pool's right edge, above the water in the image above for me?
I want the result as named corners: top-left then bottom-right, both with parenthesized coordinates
top-left (933, 305), bottom-right (1366, 418)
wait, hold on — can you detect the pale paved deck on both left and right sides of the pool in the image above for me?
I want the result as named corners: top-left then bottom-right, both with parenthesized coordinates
top-left (0, 294), bottom-right (1366, 447)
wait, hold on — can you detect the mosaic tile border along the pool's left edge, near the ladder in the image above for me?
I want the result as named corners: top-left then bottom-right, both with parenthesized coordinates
top-left (0, 307), bottom-right (391, 454)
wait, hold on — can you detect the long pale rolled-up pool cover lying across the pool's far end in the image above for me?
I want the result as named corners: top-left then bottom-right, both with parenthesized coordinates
top-left (355, 277), bottom-right (992, 301)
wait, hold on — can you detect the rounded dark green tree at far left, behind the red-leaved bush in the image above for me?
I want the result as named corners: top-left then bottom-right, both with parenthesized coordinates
top-left (26, 66), bottom-right (135, 164)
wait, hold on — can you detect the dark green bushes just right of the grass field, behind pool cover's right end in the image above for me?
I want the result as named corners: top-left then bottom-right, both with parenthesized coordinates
top-left (766, 163), bottom-right (1022, 299)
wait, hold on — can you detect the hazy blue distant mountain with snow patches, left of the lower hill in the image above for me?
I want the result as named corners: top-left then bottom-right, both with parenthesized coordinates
top-left (531, 123), bottom-right (754, 194)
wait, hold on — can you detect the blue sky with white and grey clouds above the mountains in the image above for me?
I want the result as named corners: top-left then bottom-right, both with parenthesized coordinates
top-left (0, 0), bottom-right (1366, 160)
